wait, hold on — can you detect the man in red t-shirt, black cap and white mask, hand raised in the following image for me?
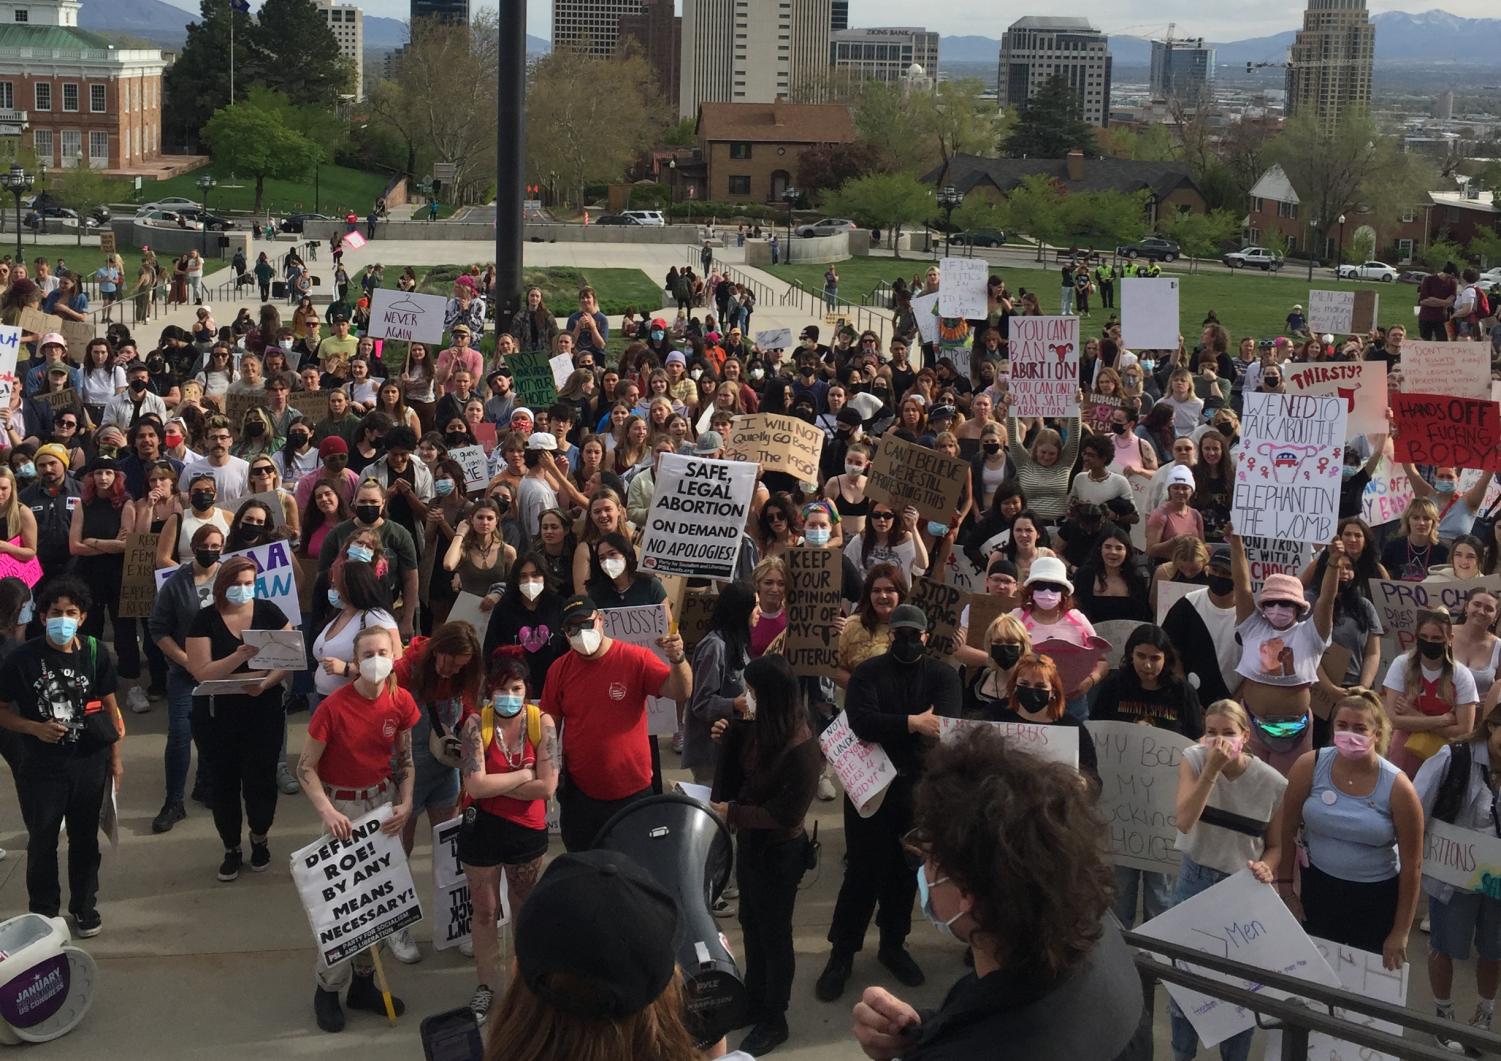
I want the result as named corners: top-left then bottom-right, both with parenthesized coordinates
top-left (543, 596), bottom-right (693, 851)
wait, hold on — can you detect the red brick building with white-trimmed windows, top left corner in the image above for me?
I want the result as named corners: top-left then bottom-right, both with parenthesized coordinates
top-left (0, 0), bottom-right (167, 174)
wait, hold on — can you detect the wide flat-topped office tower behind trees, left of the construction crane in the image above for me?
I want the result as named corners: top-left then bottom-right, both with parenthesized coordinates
top-left (998, 15), bottom-right (1111, 126)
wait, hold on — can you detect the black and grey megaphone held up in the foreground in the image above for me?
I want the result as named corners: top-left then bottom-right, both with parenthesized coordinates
top-left (593, 794), bottom-right (746, 1046)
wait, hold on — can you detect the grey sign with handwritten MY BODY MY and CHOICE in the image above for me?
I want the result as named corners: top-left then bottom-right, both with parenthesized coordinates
top-left (1084, 722), bottom-right (1193, 873)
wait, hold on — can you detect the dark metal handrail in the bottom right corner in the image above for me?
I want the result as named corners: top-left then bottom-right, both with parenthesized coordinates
top-left (1124, 932), bottom-right (1501, 1061)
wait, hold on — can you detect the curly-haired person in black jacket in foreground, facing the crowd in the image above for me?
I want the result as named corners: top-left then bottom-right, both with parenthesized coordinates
top-left (854, 732), bottom-right (1151, 1061)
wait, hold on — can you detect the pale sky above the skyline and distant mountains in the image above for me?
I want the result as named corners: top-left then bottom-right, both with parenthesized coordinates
top-left (522, 0), bottom-right (1495, 41)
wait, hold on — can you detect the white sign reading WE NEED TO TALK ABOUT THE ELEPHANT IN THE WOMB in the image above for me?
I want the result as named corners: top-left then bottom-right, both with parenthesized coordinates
top-left (1231, 392), bottom-right (1346, 543)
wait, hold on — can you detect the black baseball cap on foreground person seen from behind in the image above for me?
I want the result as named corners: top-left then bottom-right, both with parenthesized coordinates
top-left (516, 846), bottom-right (681, 1020)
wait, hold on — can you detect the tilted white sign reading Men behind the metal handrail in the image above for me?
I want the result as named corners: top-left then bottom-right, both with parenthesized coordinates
top-left (1136, 869), bottom-right (1339, 1046)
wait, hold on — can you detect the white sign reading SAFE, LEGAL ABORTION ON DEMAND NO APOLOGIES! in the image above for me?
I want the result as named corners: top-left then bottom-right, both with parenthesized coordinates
top-left (641, 453), bottom-right (757, 582)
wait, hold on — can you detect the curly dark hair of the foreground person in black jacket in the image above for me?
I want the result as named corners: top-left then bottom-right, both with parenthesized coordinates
top-left (913, 732), bottom-right (1115, 983)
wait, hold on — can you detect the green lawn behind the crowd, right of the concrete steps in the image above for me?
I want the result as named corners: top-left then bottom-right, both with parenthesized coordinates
top-left (767, 258), bottom-right (1398, 344)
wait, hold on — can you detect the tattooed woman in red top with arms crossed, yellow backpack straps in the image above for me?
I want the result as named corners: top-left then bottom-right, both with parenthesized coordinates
top-left (459, 654), bottom-right (558, 1020)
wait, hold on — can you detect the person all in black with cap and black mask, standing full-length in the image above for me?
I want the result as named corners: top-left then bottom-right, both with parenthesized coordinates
top-left (814, 605), bottom-right (961, 1002)
